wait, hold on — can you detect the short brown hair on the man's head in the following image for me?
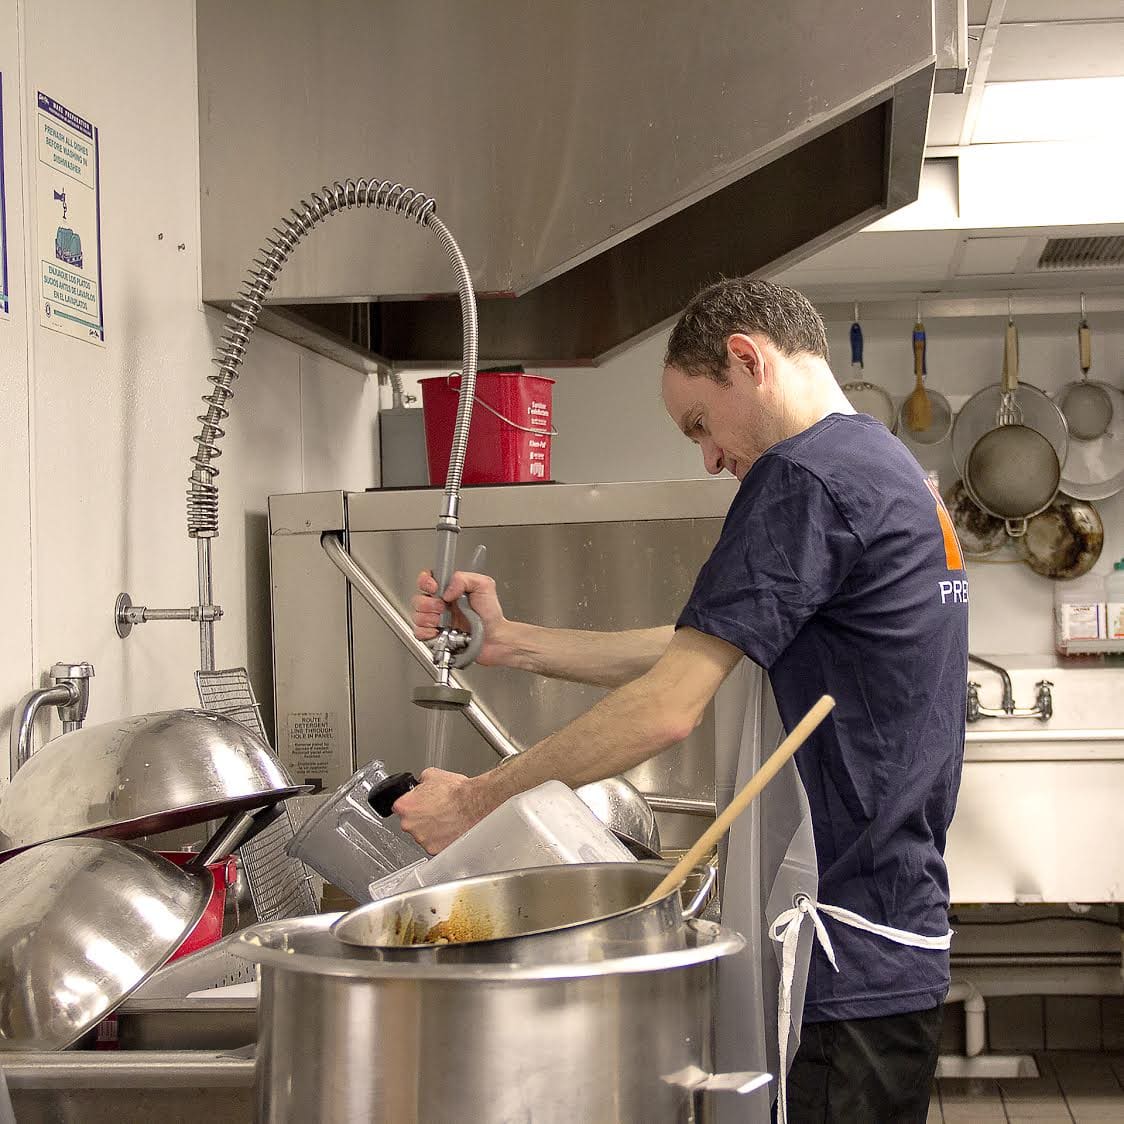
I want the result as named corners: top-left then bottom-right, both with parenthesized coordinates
top-left (663, 278), bottom-right (827, 383)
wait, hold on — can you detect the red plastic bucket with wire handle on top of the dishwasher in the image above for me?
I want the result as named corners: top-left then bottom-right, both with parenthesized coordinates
top-left (422, 370), bottom-right (555, 484)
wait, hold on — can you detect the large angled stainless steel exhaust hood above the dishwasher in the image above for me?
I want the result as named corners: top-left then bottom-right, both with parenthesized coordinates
top-left (197, 0), bottom-right (935, 363)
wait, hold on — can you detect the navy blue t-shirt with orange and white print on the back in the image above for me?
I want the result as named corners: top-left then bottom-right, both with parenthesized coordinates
top-left (677, 414), bottom-right (968, 1022)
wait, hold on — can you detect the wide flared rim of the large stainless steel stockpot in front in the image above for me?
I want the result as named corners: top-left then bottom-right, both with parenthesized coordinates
top-left (233, 913), bottom-right (745, 982)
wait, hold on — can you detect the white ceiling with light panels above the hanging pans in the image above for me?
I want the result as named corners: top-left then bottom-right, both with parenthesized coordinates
top-left (782, 0), bottom-right (1124, 300)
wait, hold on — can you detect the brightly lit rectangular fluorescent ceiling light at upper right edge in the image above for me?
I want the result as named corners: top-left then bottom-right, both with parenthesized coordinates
top-left (971, 78), bottom-right (1124, 144)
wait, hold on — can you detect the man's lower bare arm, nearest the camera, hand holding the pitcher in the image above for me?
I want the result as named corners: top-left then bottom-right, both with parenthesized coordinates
top-left (395, 628), bottom-right (744, 854)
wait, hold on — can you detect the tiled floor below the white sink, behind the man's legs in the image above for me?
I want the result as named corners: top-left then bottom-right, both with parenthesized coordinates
top-left (927, 1050), bottom-right (1124, 1124)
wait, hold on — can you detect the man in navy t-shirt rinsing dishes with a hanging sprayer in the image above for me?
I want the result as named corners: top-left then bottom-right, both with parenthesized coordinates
top-left (395, 278), bottom-right (968, 1122)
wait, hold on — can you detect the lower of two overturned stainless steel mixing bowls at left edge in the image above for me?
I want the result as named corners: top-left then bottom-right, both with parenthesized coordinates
top-left (0, 839), bottom-right (211, 1051)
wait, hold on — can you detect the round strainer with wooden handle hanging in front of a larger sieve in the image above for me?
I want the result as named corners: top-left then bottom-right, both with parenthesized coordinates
top-left (964, 319), bottom-right (1061, 538)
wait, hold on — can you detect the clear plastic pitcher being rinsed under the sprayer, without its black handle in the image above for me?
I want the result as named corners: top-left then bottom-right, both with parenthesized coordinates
top-left (287, 761), bottom-right (427, 901)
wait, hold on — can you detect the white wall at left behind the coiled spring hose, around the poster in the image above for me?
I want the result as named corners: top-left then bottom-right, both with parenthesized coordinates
top-left (0, 0), bottom-right (378, 776)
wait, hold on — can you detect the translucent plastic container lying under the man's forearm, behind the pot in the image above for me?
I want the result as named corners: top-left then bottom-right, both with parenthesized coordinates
top-left (364, 780), bottom-right (636, 901)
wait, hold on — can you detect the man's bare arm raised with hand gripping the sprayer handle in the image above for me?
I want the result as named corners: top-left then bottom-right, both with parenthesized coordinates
top-left (413, 572), bottom-right (674, 687)
